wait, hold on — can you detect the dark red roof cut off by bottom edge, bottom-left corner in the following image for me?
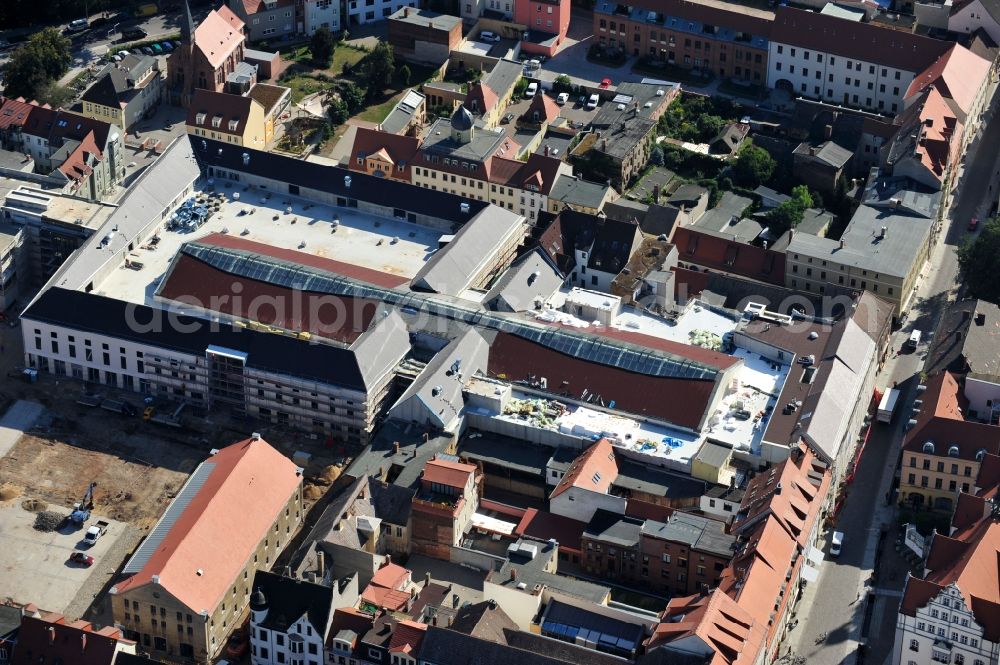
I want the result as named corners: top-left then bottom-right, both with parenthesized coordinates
top-left (10, 614), bottom-right (135, 665)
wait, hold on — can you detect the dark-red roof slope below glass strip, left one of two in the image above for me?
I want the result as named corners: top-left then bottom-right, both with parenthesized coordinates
top-left (158, 254), bottom-right (379, 344)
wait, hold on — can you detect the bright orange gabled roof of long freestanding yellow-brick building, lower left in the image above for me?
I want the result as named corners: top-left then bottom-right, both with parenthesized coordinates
top-left (113, 439), bottom-right (302, 613)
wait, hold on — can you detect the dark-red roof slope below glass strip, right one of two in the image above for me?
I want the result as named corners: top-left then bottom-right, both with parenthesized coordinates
top-left (488, 331), bottom-right (733, 428)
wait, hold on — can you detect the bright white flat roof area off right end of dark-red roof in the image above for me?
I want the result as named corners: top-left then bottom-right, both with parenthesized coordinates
top-left (704, 349), bottom-right (789, 454)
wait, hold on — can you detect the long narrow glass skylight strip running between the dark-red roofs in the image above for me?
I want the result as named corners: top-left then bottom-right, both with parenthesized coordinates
top-left (182, 242), bottom-right (718, 380)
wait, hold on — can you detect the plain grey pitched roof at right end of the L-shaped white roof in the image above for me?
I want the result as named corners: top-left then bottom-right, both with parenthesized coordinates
top-left (412, 206), bottom-right (524, 296)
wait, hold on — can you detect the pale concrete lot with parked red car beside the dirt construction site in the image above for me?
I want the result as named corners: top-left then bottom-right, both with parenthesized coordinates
top-left (0, 497), bottom-right (139, 617)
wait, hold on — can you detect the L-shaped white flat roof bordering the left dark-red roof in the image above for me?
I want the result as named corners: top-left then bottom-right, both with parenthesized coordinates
top-left (96, 182), bottom-right (441, 304)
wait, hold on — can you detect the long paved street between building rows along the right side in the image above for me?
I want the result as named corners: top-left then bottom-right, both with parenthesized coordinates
top-left (783, 80), bottom-right (1000, 665)
